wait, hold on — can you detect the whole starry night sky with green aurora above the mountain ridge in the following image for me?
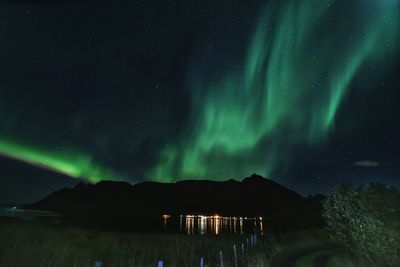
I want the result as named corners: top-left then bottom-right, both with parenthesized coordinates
top-left (0, 0), bottom-right (400, 203)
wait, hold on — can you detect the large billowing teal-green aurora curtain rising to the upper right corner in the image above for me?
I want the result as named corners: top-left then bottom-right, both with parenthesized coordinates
top-left (149, 0), bottom-right (399, 181)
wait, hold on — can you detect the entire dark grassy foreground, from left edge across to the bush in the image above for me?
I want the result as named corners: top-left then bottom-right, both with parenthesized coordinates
top-left (0, 218), bottom-right (376, 267)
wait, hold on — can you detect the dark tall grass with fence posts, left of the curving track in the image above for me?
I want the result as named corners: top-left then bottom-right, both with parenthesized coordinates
top-left (0, 221), bottom-right (271, 267)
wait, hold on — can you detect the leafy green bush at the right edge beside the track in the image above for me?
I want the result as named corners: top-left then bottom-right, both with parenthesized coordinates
top-left (323, 184), bottom-right (400, 266)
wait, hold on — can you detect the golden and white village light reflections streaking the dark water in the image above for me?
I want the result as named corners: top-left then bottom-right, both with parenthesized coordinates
top-left (162, 215), bottom-right (264, 235)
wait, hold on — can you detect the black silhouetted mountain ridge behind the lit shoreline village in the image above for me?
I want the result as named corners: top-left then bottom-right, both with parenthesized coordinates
top-left (29, 174), bottom-right (324, 231)
